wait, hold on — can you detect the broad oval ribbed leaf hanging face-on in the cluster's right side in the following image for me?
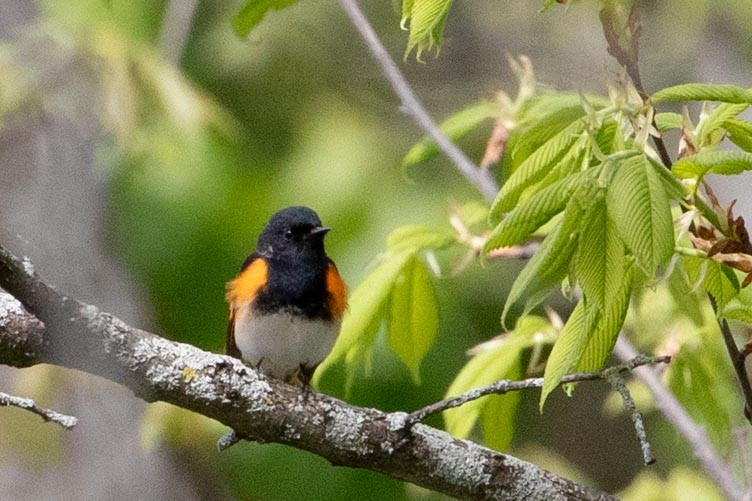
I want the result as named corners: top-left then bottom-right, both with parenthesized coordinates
top-left (606, 155), bottom-right (674, 274)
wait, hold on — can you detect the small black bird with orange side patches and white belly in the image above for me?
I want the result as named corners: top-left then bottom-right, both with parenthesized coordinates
top-left (225, 206), bottom-right (347, 386)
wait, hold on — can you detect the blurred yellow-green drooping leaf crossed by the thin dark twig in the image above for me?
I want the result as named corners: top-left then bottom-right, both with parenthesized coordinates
top-left (444, 316), bottom-right (553, 450)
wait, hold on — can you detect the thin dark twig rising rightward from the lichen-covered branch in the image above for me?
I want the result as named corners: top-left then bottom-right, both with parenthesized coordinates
top-left (406, 355), bottom-right (671, 428)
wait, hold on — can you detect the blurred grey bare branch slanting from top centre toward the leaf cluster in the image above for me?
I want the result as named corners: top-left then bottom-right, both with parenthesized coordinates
top-left (339, 0), bottom-right (499, 200)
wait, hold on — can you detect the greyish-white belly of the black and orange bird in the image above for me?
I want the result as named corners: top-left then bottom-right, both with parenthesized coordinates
top-left (235, 309), bottom-right (340, 379)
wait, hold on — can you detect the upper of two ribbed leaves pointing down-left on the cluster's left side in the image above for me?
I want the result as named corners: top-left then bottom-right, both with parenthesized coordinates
top-left (489, 120), bottom-right (585, 219)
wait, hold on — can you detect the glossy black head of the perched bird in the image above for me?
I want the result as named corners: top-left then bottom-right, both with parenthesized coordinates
top-left (256, 207), bottom-right (329, 260)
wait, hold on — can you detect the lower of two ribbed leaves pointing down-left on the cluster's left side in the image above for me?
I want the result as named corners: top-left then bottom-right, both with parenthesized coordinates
top-left (485, 171), bottom-right (593, 251)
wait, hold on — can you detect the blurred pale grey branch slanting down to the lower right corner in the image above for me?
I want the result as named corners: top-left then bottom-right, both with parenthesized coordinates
top-left (614, 336), bottom-right (748, 501)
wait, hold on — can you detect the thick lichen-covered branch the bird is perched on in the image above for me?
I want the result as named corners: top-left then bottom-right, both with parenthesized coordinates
top-left (0, 246), bottom-right (614, 500)
